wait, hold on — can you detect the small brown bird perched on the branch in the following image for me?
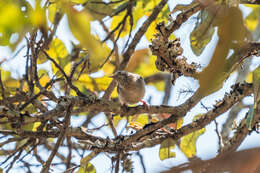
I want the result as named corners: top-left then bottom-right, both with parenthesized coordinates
top-left (111, 71), bottom-right (147, 106)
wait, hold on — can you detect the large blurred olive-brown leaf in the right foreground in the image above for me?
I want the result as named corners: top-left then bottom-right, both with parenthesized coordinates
top-left (195, 6), bottom-right (247, 97)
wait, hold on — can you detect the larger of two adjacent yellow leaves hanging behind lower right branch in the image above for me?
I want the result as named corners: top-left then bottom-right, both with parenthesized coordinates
top-left (180, 114), bottom-right (205, 158)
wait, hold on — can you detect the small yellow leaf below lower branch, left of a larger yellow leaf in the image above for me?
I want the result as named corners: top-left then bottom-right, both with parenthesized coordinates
top-left (159, 138), bottom-right (176, 160)
